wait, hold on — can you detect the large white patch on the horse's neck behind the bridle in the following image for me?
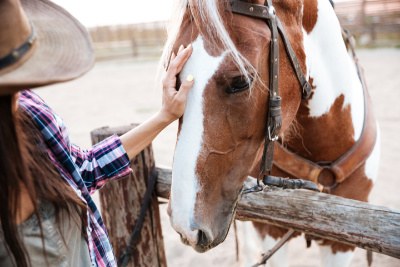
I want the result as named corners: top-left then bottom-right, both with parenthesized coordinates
top-left (303, 0), bottom-right (364, 140)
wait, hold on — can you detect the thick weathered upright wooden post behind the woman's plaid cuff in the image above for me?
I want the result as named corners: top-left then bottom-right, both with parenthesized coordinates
top-left (91, 125), bottom-right (167, 267)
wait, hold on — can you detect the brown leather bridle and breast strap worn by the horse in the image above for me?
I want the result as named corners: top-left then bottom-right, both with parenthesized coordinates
top-left (229, 0), bottom-right (377, 267)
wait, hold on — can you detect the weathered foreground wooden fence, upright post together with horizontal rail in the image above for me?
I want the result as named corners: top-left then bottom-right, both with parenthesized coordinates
top-left (92, 126), bottom-right (400, 266)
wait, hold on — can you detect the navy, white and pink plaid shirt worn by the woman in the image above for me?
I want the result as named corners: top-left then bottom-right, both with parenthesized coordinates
top-left (18, 91), bottom-right (131, 266)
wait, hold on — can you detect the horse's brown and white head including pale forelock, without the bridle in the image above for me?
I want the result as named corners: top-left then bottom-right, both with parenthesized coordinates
top-left (164, 0), bottom-right (306, 252)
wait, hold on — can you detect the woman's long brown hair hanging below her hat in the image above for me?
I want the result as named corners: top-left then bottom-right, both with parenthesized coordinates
top-left (0, 95), bottom-right (87, 267)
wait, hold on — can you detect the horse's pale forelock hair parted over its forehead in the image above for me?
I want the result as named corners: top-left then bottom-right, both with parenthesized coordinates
top-left (160, 0), bottom-right (253, 79)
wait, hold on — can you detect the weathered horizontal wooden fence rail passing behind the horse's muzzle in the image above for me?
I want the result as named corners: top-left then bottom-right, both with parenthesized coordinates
top-left (156, 168), bottom-right (400, 258)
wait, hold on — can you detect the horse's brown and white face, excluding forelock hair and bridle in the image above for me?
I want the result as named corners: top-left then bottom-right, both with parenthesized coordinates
top-left (167, 2), bottom-right (300, 252)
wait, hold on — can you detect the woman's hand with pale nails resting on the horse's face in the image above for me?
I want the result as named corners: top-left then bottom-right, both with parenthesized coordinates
top-left (160, 44), bottom-right (194, 122)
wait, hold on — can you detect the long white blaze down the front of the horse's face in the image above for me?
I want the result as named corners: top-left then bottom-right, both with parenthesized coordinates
top-left (170, 35), bottom-right (225, 244)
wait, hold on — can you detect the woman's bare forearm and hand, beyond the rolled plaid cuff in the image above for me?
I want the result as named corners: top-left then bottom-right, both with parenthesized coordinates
top-left (120, 45), bottom-right (193, 159)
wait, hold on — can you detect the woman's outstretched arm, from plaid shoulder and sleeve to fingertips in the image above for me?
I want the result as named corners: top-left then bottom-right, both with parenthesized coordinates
top-left (19, 45), bottom-right (193, 193)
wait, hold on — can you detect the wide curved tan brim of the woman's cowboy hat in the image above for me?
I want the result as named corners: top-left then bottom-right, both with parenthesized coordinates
top-left (0, 0), bottom-right (95, 91)
